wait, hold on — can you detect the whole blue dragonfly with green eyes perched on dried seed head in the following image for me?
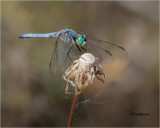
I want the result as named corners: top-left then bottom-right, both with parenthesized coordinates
top-left (19, 29), bottom-right (127, 74)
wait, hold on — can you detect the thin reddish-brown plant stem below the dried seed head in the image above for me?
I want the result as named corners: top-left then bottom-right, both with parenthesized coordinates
top-left (68, 92), bottom-right (79, 128)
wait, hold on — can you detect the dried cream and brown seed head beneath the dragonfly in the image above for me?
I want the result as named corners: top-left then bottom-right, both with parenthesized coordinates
top-left (63, 53), bottom-right (105, 93)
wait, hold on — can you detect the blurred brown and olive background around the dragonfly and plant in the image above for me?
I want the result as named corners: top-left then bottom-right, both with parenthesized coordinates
top-left (1, 1), bottom-right (159, 127)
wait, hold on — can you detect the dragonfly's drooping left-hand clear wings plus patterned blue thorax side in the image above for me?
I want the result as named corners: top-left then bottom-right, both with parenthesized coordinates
top-left (50, 33), bottom-right (81, 73)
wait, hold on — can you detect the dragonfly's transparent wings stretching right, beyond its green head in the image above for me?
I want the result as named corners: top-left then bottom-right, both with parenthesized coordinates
top-left (81, 33), bottom-right (127, 63)
